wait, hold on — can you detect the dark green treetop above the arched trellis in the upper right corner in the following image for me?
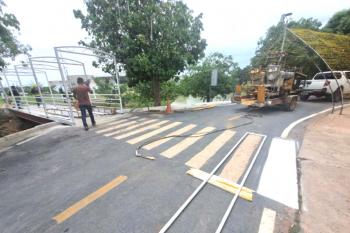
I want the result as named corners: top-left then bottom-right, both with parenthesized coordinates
top-left (323, 9), bottom-right (350, 35)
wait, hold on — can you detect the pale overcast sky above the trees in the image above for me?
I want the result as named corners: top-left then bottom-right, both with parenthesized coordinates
top-left (5, 0), bottom-right (350, 83)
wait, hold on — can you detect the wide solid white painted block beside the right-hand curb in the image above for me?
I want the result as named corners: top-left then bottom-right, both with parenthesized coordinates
top-left (257, 138), bottom-right (298, 209)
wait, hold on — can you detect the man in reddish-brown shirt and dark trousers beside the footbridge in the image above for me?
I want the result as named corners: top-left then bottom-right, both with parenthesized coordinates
top-left (73, 77), bottom-right (96, 130)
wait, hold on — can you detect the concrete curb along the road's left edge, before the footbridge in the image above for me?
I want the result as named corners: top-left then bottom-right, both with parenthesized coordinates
top-left (0, 122), bottom-right (60, 148)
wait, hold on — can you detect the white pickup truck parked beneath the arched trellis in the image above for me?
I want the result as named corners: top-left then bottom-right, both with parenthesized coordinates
top-left (300, 71), bottom-right (350, 102)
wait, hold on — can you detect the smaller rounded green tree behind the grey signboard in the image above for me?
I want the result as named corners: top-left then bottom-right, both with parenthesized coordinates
top-left (181, 53), bottom-right (239, 102)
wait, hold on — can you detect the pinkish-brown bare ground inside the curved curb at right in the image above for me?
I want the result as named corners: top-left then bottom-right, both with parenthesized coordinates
top-left (299, 107), bottom-right (350, 233)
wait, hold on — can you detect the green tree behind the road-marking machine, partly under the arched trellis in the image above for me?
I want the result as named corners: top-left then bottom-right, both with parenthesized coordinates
top-left (251, 18), bottom-right (324, 76)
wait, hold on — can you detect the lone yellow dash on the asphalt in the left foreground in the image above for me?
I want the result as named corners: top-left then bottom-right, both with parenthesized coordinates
top-left (53, 176), bottom-right (128, 224)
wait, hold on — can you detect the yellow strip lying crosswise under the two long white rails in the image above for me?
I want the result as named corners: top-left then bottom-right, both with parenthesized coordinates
top-left (186, 168), bottom-right (254, 201)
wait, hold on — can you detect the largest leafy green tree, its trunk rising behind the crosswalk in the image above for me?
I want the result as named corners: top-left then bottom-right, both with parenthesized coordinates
top-left (74, 0), bottom-right (206, 106)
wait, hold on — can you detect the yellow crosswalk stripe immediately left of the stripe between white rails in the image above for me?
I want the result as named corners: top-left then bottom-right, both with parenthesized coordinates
top-left (186, 130), bottom-right (235, 169)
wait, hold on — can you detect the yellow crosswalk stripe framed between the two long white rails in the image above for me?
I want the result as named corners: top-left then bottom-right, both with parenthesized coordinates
top-left (220, 134), bottom-right (262, 182)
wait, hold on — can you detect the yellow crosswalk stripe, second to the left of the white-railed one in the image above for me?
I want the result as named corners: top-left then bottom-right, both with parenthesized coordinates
top-left (161, 127), bottom-right (215, 158)
